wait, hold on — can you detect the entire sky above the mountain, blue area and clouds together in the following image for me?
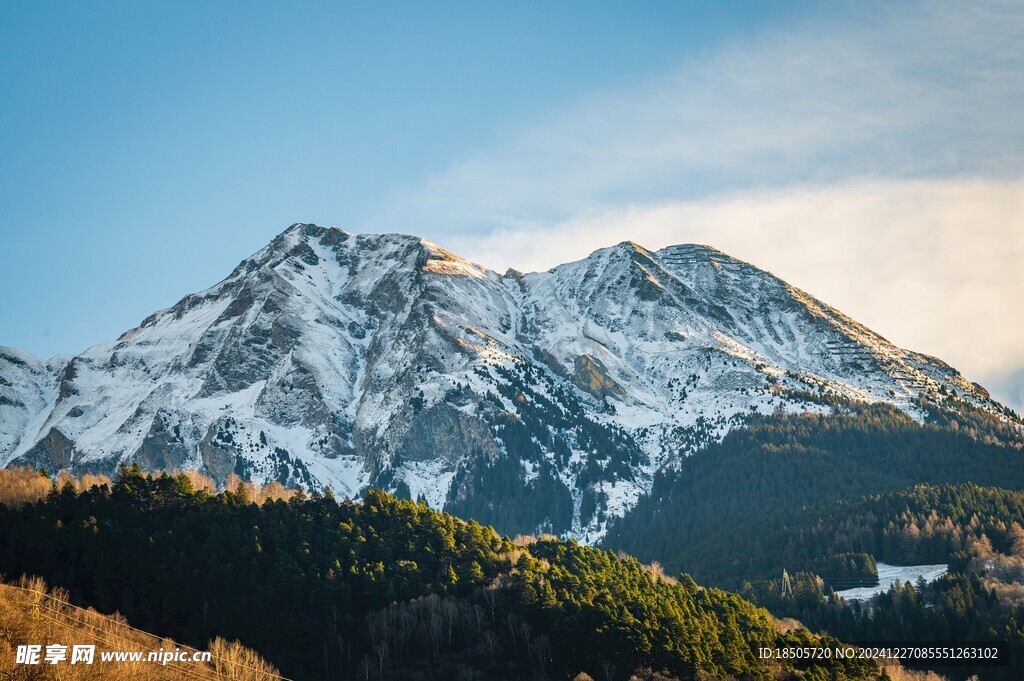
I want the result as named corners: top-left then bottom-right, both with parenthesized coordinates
top-left (0, 1), bottom-right (1024, 403)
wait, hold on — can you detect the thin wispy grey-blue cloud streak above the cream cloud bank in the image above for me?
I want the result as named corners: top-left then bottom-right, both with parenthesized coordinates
top-left (383, 2), bottom-right (1024, 232)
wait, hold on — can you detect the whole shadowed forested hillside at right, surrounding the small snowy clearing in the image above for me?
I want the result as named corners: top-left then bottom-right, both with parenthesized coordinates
top-left (605, 403), bottom-right (1024, 679)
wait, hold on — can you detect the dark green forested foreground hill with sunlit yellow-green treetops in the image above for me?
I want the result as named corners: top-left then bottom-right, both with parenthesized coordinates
top-left (0, 469), bottom-right (881, 679)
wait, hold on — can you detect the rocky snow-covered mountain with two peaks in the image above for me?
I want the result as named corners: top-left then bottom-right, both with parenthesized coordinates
top-left (0, 224), bottom-right (1001, 541)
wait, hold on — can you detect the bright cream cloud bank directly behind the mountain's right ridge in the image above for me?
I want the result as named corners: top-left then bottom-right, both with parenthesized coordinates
top-left (446, 180), bottom-right (1024, 411)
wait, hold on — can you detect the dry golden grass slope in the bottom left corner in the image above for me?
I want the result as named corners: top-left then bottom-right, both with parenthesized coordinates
top-left (0, 578), bottom-right (282, 681)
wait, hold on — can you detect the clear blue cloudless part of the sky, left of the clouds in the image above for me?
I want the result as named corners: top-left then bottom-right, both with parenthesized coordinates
top-left (0, 1), bottom-right (805, 356)
